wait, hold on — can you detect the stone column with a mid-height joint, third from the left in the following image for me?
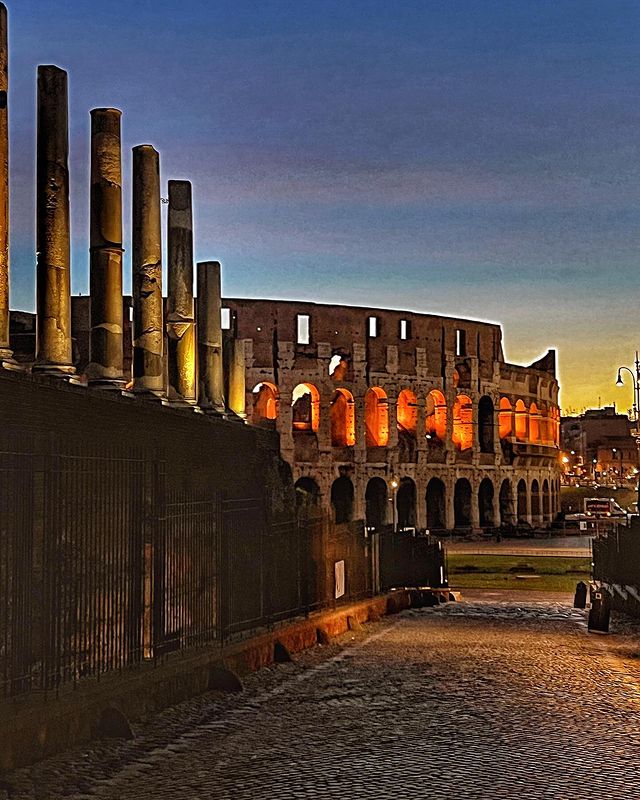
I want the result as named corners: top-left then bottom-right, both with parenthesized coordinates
top-left (87, 108), bottom-right (125, 388)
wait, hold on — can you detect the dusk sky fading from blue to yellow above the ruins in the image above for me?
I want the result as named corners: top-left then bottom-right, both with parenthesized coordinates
top-left (5, 0), bottom-right (640, 412)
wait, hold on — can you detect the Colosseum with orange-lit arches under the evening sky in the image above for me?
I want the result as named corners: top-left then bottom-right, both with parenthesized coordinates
top-left (222, 299), bottom-right (560, 531)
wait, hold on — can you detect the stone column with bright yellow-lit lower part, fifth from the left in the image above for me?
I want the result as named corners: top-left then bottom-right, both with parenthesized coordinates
top-left (167, 181), bottom-right (198, 404)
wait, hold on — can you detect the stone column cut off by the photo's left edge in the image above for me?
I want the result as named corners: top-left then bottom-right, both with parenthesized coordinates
top-left (0, 3), bottom-right (14, 366)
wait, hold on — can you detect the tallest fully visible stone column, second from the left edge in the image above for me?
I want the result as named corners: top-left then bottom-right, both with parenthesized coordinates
top-left (33, 66), bottom-right (75, 377)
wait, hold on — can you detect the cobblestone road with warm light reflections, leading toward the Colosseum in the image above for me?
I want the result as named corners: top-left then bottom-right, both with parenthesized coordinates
top-left (5, 599), bottom-right (640, 800)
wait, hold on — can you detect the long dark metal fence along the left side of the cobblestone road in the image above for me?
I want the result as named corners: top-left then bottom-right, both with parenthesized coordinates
top-left (0, 431), bottom-right (384, 698)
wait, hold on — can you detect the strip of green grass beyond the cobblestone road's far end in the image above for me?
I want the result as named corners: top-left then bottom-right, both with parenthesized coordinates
top-left (447, 553), bottom-right (591, 592)
